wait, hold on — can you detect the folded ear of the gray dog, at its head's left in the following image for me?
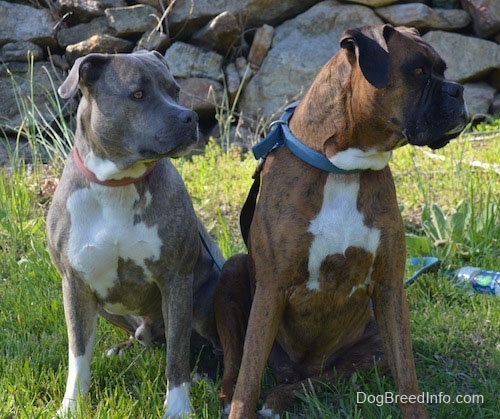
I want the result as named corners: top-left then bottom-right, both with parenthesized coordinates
top-left (57, 54), bottom-right (109, 99)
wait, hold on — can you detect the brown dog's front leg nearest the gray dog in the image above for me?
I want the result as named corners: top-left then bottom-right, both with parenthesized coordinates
top-left (229, 279), bottom-right (284, 419)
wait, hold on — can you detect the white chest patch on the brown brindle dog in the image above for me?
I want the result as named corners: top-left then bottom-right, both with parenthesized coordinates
top-left (307, 175), bottom-right (380, 290)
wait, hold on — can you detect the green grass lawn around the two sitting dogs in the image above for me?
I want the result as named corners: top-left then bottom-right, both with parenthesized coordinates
top-left (0, 78), bottom-right (500, 419)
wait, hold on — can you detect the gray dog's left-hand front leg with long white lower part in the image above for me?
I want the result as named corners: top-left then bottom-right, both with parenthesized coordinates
top-left (57, 278), bottom-right (97, 416)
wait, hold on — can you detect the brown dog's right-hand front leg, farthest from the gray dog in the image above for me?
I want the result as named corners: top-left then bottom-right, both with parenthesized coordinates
top-left (373, 279), bottom-right (428, 419)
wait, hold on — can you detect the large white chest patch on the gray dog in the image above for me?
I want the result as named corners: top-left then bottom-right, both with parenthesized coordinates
top-left (67, 184), bottom-right (162, 298)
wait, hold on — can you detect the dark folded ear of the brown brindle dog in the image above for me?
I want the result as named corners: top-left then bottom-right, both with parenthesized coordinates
top-left (340, 24), bottom-right (395, 89)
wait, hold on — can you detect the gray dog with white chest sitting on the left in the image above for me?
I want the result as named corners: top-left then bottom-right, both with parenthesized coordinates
top-left (47, 52), bottom-right (223, 417)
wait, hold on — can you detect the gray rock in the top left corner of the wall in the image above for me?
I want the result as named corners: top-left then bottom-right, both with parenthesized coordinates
top-left (0, 1), bottom-right (56, 46)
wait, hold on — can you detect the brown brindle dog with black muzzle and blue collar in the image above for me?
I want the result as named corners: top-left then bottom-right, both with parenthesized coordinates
top-left (215, 25), bottom-right (468, 419)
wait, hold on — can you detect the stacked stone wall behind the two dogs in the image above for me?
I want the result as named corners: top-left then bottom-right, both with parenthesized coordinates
top-left (0, 0), bottom-right (500, 148)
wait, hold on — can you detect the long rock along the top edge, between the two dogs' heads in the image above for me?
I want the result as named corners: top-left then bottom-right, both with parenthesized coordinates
top-left (168, 0), bottom-right (317, 39)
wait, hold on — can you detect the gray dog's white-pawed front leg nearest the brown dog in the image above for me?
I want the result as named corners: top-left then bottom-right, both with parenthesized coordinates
top-left (162, 275), bottom-right (193, 419)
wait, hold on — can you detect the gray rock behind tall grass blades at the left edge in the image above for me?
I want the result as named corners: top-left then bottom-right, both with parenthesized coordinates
top-left (0, 62), bottom-right (63, 132)
